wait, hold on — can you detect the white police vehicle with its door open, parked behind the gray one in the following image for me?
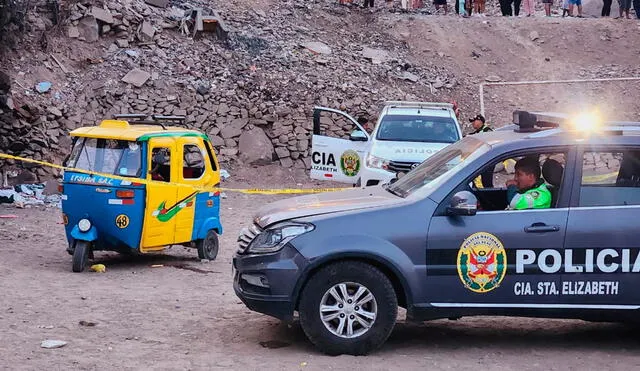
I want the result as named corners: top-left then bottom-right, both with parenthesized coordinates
top-left (311, 101), bottom-right (462, 186)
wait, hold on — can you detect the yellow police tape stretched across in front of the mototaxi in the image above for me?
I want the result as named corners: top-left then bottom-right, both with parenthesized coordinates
top-left (0, 153), bottom-right (353, 195)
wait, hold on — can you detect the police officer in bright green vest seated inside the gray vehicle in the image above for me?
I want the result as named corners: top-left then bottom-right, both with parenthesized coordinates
top-left (506, 156), bottom-right (551, 210)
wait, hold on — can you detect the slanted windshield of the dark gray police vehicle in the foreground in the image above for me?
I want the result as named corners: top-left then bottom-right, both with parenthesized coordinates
top-left (387, 137), bottom-right (490, 197)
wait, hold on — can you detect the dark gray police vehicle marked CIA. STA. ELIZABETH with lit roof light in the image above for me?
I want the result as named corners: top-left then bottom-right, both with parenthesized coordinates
top-left (233, 111), bottom-right (640, 355)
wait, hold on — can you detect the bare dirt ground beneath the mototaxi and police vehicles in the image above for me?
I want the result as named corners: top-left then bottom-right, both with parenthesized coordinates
top-left (0, 167), bottom-right (640, 370)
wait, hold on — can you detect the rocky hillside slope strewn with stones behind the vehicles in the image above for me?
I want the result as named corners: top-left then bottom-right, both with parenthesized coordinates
top-left (0, 0), bottom-right (640, 182)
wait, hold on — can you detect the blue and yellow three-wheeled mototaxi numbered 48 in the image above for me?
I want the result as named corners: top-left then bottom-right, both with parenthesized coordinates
top-left (62, 114), bottom-right (222, 272)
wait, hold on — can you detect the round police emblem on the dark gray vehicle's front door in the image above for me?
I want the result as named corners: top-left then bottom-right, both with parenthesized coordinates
top-left (457, 232), bottom-right (507, 293)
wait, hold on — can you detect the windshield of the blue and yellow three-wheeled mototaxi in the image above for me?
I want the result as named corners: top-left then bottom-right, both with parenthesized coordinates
top-left (66, 138), bottom-right (142, 177)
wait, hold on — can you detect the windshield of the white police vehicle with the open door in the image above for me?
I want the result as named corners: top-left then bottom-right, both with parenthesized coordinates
top-left (377, 115), bottom-right (460, 143)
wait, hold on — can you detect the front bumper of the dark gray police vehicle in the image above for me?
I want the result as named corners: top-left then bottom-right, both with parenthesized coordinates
top-left (233, 245), bottom-right (307, 321)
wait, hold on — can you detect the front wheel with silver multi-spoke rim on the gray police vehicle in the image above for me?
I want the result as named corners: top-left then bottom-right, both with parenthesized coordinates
top-left (298, 261), bottom-right (398, 355)
